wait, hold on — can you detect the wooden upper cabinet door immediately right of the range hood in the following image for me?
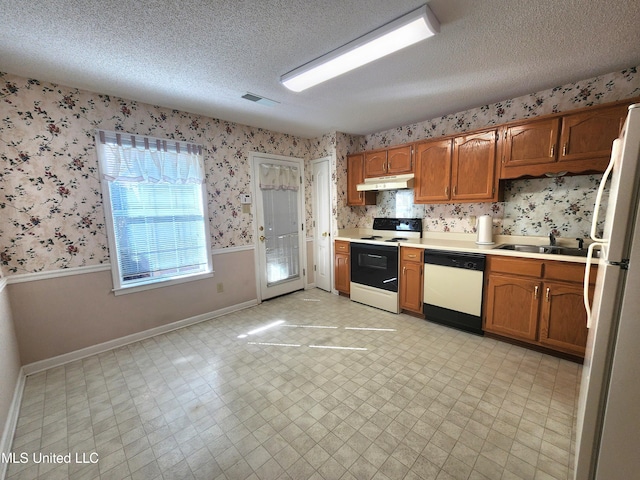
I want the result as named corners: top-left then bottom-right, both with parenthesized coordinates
top-left (414, 139), bottom-right (452, 203)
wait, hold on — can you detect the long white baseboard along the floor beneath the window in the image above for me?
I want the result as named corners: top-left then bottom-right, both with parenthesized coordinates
top-left (21, 299), bottom-right (258, 376)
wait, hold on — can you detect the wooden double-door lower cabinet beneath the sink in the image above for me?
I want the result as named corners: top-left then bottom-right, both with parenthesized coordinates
top-left (483, 256), bottom-right (596, 357)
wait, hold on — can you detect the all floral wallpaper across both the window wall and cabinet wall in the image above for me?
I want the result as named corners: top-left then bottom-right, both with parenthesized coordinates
top-left (0, 67), bottom-right (640, 276)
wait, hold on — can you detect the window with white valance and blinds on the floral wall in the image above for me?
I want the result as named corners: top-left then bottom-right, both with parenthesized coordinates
top-left (96, 131), bottom-right (212, 293)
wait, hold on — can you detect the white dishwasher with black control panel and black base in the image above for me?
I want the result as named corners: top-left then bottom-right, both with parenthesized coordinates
top-left (423, 250), bottom-right (486, 335)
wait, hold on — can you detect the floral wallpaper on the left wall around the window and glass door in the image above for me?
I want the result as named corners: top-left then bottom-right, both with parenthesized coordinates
top-left (0, 73), bottom-right (335, 275)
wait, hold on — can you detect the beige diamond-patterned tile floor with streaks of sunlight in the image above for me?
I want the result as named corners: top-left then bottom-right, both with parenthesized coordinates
top-left (7, 290), bottom-right (581, 480)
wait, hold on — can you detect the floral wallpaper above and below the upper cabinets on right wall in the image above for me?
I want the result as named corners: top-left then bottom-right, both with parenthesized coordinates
top-left (337, 67), bottom-right (640, 238)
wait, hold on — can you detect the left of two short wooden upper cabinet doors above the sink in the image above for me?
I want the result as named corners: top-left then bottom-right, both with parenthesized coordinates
top-left (502, 118), bottom-right (560, 170)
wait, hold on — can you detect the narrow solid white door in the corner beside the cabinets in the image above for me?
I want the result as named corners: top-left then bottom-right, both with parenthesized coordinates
top-left (312, 157), bottom-right (332, 292)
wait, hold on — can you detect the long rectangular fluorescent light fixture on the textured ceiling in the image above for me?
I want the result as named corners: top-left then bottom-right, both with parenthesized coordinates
top-left (280, 5), bottom-right (440, 92)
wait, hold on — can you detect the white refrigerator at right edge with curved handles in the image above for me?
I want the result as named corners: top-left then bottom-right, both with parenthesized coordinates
top-left (575, 104), bottom-right (640, 480)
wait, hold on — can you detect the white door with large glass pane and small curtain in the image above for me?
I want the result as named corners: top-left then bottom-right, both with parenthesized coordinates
top-left (252, 154), bottom-right (306, 300)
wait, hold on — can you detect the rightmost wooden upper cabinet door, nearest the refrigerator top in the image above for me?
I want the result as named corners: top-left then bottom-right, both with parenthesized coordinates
top-left (558, 104), bottom-right (628, 162)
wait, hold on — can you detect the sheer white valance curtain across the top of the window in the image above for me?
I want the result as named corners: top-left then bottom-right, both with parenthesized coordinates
top-left (98, 130), bottom-right (204, 184)
